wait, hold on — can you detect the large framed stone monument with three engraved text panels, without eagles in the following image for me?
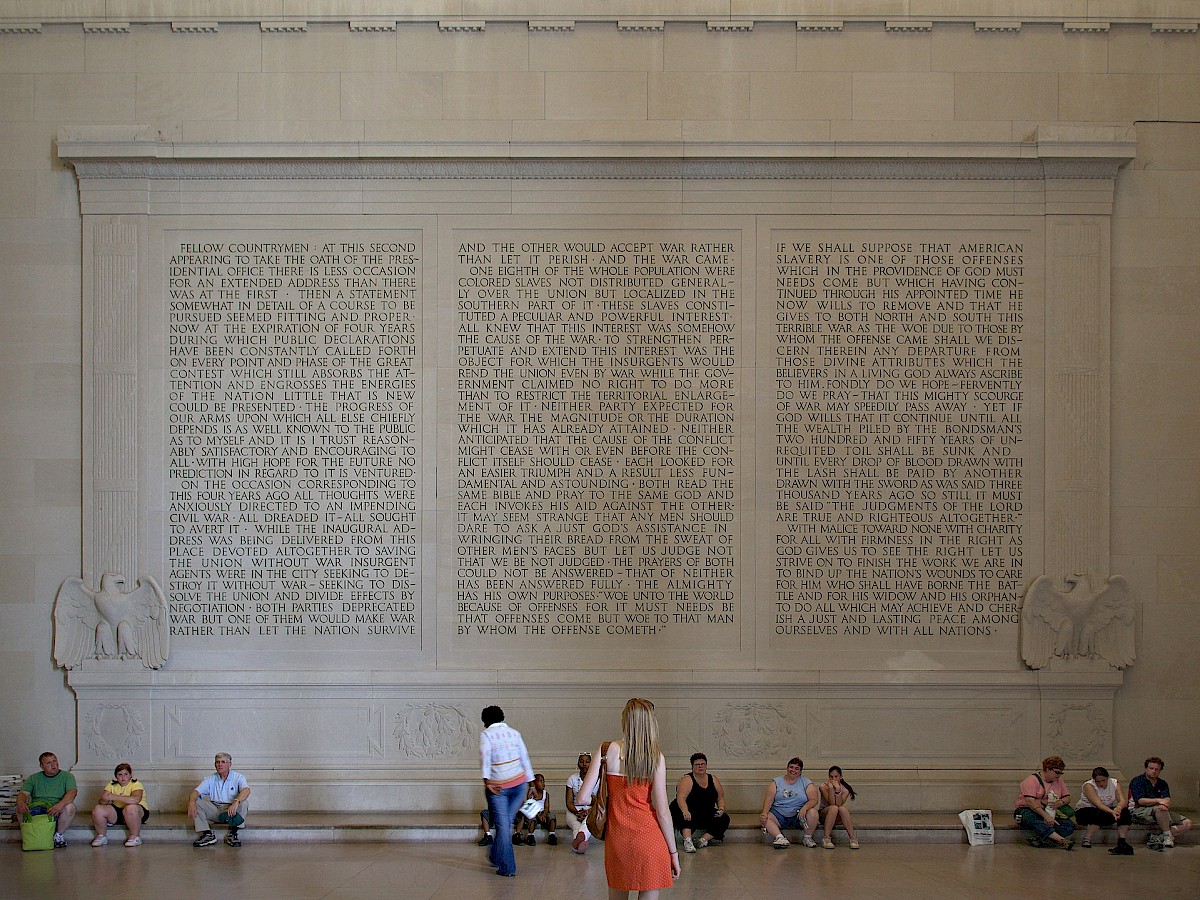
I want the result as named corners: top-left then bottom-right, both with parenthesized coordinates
top-left (59, 130), bottom-right (1133, 809)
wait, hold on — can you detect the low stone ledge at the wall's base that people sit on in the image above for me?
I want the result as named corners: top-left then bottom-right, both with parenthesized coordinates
top-left (4, 810), bottom-right (1140, 845)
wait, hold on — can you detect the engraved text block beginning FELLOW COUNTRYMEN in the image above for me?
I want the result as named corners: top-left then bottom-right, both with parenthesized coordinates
top-left (164, 232), bottom-right (421, 650)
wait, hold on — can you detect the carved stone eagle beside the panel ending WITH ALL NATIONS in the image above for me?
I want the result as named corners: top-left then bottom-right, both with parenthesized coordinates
top-left (1021, 575), bottom-right (1136, 668)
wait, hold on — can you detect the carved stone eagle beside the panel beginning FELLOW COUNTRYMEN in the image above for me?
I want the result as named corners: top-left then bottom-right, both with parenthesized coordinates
top-left (54, 572), bottom-right (170, 668)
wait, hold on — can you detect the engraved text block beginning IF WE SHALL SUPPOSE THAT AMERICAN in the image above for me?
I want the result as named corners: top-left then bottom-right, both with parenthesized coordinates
top-left (772, 230), bottom-right (1028, 649)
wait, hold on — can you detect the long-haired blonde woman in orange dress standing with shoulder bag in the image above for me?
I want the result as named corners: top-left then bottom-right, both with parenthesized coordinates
top-left (578, 697), bottom-right (679, 900)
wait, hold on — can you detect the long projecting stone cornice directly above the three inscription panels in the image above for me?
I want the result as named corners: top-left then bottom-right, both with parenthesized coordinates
top-left (58, 125), bottom-right (1136, 180)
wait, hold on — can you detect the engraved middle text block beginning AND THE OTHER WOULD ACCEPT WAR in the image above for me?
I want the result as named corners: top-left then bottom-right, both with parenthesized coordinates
top-left (454, 230), bottom-right (740, 649)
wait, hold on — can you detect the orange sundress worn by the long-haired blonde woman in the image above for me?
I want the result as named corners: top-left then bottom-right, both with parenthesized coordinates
top-left (604, 775), bottom-right (674, 890)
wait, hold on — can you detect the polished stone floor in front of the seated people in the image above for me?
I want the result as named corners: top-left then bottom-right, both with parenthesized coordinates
top-left (9, 829), bottom-right (1200, 900)
